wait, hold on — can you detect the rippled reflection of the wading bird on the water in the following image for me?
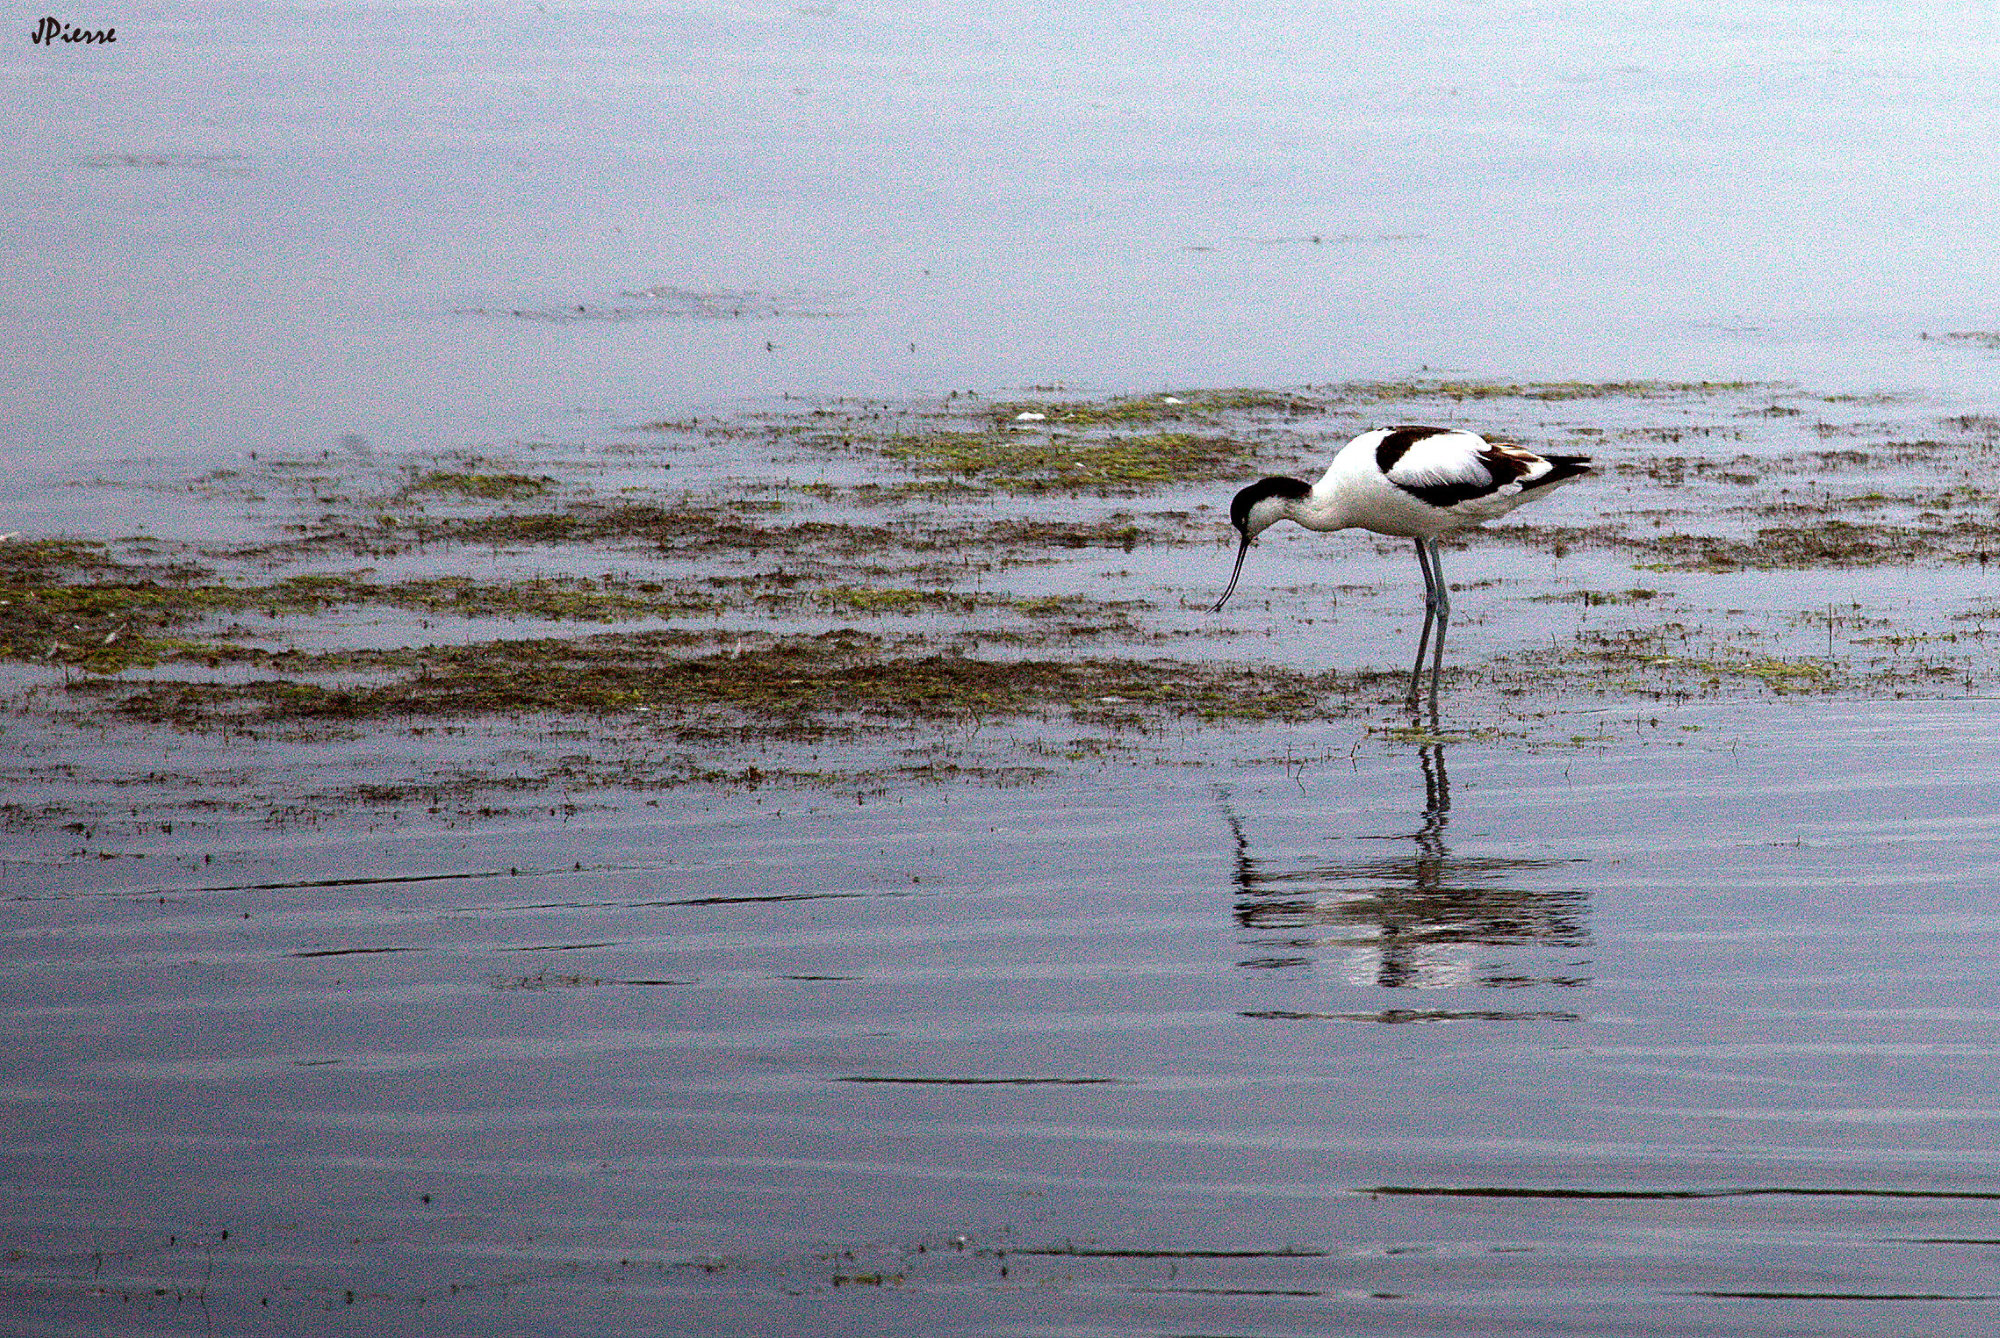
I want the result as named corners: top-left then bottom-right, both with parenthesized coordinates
top-left (1222, 744), bottom-right (1590, 1000)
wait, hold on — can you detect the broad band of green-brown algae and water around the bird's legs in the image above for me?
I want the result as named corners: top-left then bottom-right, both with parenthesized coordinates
top-left (0, 380), bottom-right (2000, 828)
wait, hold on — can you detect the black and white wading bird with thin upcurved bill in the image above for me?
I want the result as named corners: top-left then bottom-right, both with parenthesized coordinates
top-left (1216, 426), bottom-right (1590, 716)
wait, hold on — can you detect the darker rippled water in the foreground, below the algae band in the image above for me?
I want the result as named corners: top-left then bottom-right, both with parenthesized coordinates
top-left (0, 702), bottom-right (2000, 1334)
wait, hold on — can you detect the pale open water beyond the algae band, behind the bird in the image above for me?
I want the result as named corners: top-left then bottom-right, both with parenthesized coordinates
top-left (11, 0), bottom-right (2000, 470)
